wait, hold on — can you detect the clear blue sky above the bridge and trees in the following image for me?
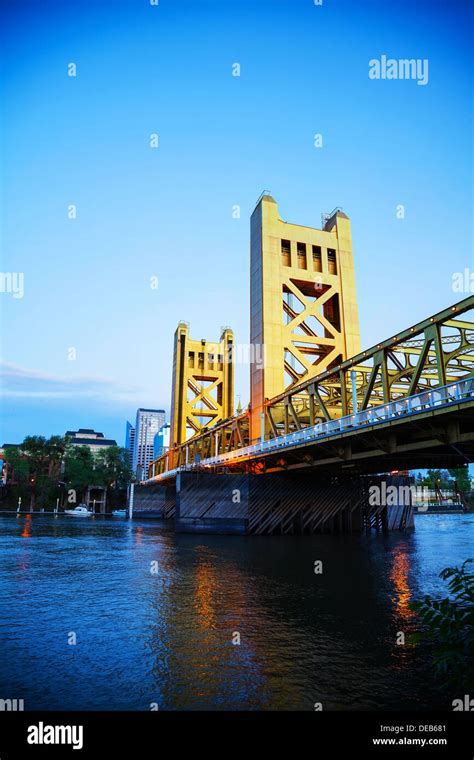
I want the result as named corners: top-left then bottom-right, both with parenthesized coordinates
top-left (0, 0), bottom-right (473, 444)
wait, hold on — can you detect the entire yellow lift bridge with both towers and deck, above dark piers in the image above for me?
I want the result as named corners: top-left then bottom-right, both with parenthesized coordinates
top-left (140, 194), bottom-right (474, 532)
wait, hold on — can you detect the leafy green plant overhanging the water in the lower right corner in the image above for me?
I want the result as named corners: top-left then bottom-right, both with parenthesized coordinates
top-left (410, 559), bottom-right (474, 687)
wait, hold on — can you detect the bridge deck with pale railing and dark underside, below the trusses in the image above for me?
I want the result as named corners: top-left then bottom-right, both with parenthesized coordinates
top-left (146, 377), bottom-right (474, 484)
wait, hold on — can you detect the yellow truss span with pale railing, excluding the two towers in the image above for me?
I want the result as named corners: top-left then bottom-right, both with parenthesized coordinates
top-left (148, 296), bottom-right (474, 482)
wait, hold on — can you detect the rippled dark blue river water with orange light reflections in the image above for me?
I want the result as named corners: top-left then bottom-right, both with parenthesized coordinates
top-left (0, 514), bottom-right (474, 710)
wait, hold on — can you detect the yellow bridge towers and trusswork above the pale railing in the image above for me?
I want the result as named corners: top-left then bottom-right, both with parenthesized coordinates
top-left (149, 188), bottom-right (474, 477)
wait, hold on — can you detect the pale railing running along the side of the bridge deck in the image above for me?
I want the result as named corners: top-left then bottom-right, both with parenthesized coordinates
top-left (146, 376), bottom-right (474, 477)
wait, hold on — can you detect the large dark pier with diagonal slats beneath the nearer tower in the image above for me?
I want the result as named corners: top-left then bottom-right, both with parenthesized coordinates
top-left (175, 472), bottom-right (413, 535)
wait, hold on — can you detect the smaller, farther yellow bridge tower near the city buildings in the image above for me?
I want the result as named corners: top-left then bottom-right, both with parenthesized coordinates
top-left (170, 322), bottom-right (234, 446)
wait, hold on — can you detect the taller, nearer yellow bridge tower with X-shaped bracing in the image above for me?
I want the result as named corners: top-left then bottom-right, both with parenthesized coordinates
top-left (250, 194), bottom-right (360, 440)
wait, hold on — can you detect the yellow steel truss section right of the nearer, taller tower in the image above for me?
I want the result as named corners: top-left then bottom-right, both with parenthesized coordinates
top-left (266, 296), bottom-right (474, 437)
